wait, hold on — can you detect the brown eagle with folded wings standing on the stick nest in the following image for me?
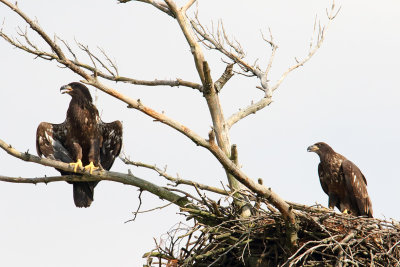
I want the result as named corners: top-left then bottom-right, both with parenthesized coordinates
top-left (307, 142), bottom-right (372, 218)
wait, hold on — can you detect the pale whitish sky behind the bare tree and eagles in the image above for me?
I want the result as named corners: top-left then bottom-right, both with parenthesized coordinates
top-left (0, 0), bottom-right (400, 267)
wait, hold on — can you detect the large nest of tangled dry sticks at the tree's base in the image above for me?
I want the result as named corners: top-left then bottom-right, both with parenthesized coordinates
top-left (144, 200), bottom-right (400, 267)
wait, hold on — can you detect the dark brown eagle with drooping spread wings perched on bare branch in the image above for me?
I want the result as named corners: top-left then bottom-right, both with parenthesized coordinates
top-left (36, 82), bottom-right (122, 208)
